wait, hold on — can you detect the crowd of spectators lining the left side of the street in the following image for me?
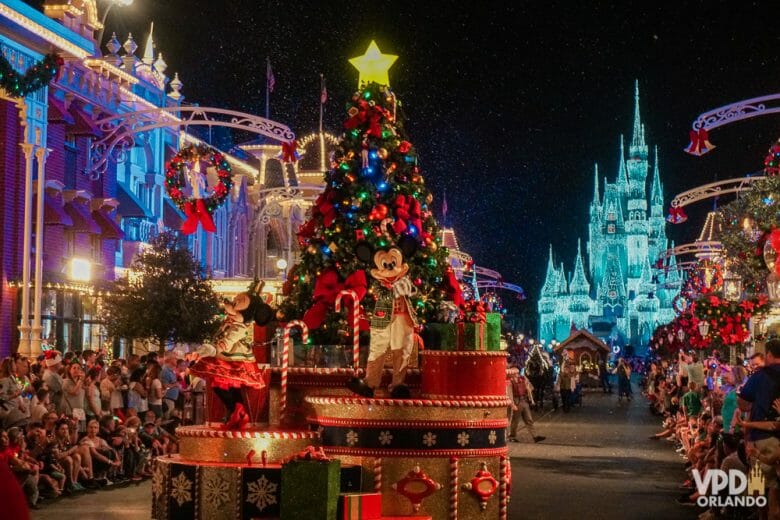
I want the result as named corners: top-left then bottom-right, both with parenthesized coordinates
top-left (0, 350), bottom-right (204, 508)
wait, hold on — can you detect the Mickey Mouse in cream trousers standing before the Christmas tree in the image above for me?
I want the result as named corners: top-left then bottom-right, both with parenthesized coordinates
top-left (348, 240), bottom-right (417, 399)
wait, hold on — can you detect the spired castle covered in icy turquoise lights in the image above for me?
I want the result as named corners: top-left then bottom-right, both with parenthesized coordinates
top-left (539, 82), bottom-right (680, 354)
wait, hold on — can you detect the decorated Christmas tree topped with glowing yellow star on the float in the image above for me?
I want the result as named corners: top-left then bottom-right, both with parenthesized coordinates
top-left (279, 42), bottom-right (459, 344)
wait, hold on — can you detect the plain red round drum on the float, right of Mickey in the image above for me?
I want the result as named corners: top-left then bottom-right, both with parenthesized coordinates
top-left (420, 350), bottom-right (507, 399)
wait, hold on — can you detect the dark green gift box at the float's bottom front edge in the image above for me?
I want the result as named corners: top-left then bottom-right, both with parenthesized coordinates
top-left (280, 460), bottom-right (341, 520)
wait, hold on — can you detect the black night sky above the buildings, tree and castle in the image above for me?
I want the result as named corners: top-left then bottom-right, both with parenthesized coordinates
top-left (24, 0), bottom-right (780, 324)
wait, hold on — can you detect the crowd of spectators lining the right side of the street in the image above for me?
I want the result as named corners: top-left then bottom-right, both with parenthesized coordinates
top-left (645, 340), bottom-right (780, 520)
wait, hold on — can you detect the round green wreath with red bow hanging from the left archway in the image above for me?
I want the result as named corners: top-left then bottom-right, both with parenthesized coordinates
top-left (165, 144), bottom-right (233, 235)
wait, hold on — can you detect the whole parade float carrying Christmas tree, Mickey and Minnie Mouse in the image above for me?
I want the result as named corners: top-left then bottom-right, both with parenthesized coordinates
top-left (152, 42), bottom-right (511, 520)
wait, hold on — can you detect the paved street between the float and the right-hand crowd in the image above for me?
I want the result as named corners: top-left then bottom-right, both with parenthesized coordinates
top-left (509, 385), bottom-right (701, 520)
